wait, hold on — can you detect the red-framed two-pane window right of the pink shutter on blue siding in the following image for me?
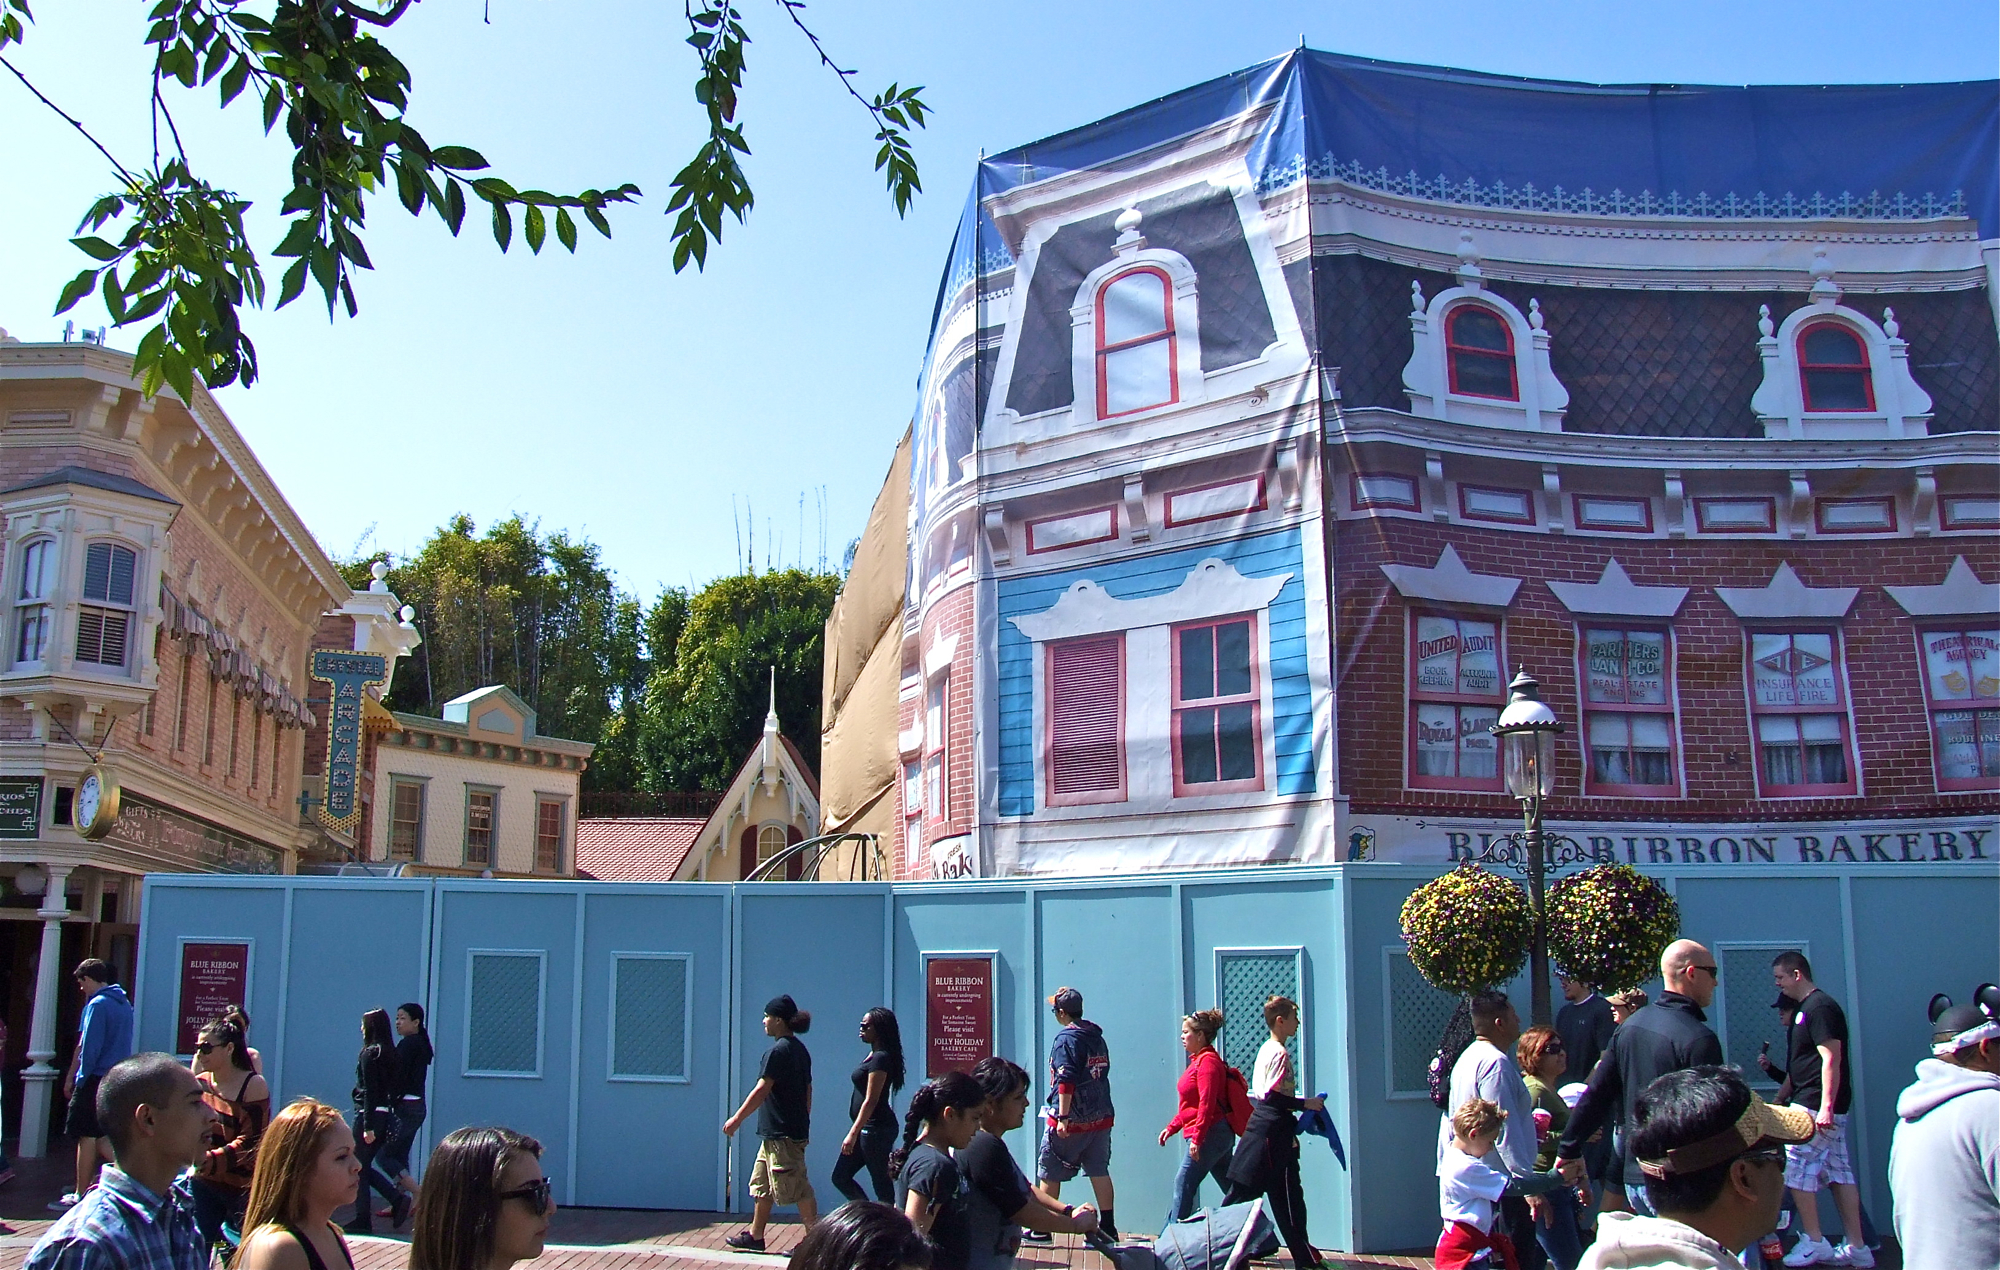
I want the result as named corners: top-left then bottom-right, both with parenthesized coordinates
top-left (1174, 616), bottom-right (1264, 794)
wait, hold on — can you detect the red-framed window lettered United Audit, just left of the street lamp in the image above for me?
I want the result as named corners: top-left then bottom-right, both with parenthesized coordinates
top-left (1410, 614), bottom-right (1502, 790)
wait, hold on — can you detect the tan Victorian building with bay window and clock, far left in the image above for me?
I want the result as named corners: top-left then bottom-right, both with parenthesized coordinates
top-left (0, 332), bottom-right (416, 1156)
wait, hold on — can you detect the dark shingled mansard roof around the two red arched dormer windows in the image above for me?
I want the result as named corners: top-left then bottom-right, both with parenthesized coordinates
top-left (1294, 254), bottom-right (2000, 438)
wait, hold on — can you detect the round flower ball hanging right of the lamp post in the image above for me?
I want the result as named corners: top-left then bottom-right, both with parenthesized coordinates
top-left (1536, 864), bottom-right (1680, 992)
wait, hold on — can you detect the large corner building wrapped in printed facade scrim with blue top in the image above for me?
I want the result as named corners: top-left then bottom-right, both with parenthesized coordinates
top-left (824, 50), bottom-right (2000, 876)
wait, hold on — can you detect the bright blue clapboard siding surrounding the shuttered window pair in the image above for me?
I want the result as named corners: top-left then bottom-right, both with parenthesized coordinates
top-left (996, 528), bottom-right (1314, 816)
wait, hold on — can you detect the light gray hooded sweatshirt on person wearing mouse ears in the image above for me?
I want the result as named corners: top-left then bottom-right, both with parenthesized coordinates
top-left (1888, 1058), bottom-right (2000, 1270)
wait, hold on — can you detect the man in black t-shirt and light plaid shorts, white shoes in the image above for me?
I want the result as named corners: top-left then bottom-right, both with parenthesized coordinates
top-left (1770, 950), bottom-right (1874, 1266)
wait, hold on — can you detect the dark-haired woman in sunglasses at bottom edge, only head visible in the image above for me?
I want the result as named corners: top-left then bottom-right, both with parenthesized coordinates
top-left (410, 1128), bottom-right (556, 1270)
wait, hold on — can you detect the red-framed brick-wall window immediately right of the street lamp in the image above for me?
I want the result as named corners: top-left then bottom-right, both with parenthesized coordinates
top-left (1582, 626), bottom-right (1680, 796)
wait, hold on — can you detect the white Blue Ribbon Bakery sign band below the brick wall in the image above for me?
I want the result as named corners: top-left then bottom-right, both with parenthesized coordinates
top-left (1342, 816), bottom-right (2000, 868)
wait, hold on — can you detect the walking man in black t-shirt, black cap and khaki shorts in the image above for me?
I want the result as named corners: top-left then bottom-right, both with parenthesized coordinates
top-left (722, 996), bottom-right (820, 1252)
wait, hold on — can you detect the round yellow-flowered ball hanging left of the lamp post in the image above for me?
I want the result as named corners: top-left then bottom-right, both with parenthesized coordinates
top-left (1402, 864), bottom-right (1534, 996)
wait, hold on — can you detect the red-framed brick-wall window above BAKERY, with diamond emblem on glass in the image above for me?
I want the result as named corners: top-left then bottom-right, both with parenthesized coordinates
top-left (1750, 630), bottom-right (1854, 796)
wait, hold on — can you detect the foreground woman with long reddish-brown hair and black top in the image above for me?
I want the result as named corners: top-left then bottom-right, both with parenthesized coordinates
top-left (234, 1098), bottom-right (362, 1270)
